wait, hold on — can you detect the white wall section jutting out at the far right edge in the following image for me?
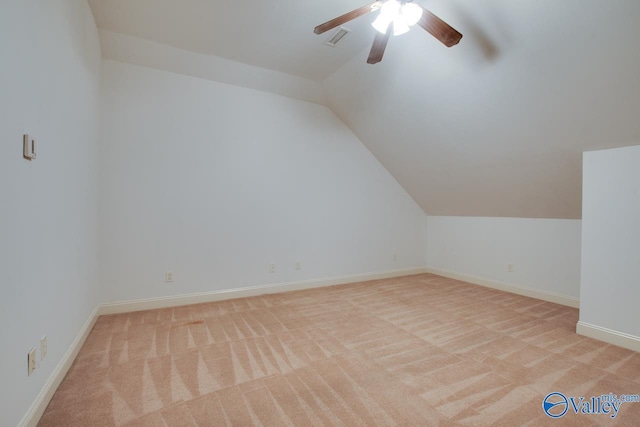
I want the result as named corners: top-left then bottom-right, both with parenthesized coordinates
top-left (580, 146), bottom-right (640, 339)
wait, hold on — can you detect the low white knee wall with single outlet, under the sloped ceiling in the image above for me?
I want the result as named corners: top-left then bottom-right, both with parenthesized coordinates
top-left (427, 216), bottom-right (580, 299)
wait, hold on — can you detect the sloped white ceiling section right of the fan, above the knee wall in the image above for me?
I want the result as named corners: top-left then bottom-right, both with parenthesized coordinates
top-left (324, 0), bottom-right (640, 218)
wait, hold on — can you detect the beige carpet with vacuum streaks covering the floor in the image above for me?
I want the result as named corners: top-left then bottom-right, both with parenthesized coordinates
top-left (39, 274), bottom-right (640, 426)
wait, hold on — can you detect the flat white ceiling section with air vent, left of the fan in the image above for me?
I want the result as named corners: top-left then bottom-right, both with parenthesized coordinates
top-left (89, 0), bottom-right (375, 81)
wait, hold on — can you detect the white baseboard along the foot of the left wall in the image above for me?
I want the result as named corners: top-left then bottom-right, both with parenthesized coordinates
top-left (18, 307), bottom-right (98, 427)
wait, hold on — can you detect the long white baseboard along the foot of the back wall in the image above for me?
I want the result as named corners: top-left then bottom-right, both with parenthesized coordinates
top-left (98, 267), bottom-right (427, 315)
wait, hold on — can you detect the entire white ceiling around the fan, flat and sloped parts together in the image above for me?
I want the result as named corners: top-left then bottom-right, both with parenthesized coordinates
top-left (89, 0), bottom-right (640, 218)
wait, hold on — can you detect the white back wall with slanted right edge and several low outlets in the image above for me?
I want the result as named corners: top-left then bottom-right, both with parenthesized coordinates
top-left (100, 60), bottom-right (426, 302)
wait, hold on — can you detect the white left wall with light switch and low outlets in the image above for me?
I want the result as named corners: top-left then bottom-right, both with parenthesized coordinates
top-left (0, 0), bottom-right (100, 426)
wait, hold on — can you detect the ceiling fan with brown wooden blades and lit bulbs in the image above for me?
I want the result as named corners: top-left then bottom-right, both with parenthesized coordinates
top-left (313, 0), bottom-right (462, 64)
